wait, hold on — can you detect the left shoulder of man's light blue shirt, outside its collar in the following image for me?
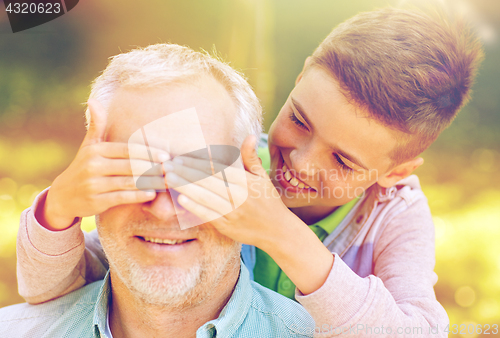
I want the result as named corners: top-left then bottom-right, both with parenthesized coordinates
top-left (0, 280), bottom-right (103, 337)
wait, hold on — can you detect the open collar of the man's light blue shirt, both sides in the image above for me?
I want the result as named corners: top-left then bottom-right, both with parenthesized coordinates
top-left (92, 260), bottom-right (252, 338)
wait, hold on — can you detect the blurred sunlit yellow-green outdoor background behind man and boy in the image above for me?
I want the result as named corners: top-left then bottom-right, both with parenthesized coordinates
top-left (0, 0), bottom-right (500, 337)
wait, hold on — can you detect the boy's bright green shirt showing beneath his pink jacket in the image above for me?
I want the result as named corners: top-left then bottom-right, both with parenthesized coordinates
top-left (253, 147), bottom-right (358, 299)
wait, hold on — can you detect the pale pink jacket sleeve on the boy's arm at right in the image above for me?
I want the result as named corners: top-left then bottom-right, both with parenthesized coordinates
top-left (296, 197), bottom-right (449, 337)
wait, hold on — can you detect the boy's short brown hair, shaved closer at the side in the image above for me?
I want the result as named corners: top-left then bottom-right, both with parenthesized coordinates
top-left (309, 8), bottom-right (483, 165)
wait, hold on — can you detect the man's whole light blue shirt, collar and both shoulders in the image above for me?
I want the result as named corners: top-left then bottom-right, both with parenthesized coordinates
top-left (0, 263), bottom-right (314, 338)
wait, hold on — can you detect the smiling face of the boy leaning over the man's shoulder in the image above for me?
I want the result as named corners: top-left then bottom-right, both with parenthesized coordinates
top-left (269, 66), bottom-right (397, 218)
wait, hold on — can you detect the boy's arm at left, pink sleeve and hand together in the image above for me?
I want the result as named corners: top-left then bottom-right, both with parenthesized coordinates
top-left (17, 100), bottom-right (170, 303)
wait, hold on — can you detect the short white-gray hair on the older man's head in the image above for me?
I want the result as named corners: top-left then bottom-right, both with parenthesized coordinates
top-left (85, 43), bottom-right (262, 146)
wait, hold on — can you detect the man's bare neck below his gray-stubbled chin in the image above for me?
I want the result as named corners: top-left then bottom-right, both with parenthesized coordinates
top-left (109, 263), bottom-right (240, 338)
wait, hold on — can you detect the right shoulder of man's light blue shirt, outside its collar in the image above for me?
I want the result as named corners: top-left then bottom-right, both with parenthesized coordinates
top-left (237, 281), bottom-right (314, 337)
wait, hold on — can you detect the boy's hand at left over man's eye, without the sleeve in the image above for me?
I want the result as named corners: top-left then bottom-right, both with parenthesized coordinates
top-left (36, 100), bottom-right (170, 231)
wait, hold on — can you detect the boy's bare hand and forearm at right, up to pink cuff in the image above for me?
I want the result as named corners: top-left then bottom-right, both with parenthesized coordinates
top-left (164, 136), bottom-right (334, 294)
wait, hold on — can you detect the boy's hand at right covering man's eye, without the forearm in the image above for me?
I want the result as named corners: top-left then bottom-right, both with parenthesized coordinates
top-left (164, 136), bottom-right (302, 250)
